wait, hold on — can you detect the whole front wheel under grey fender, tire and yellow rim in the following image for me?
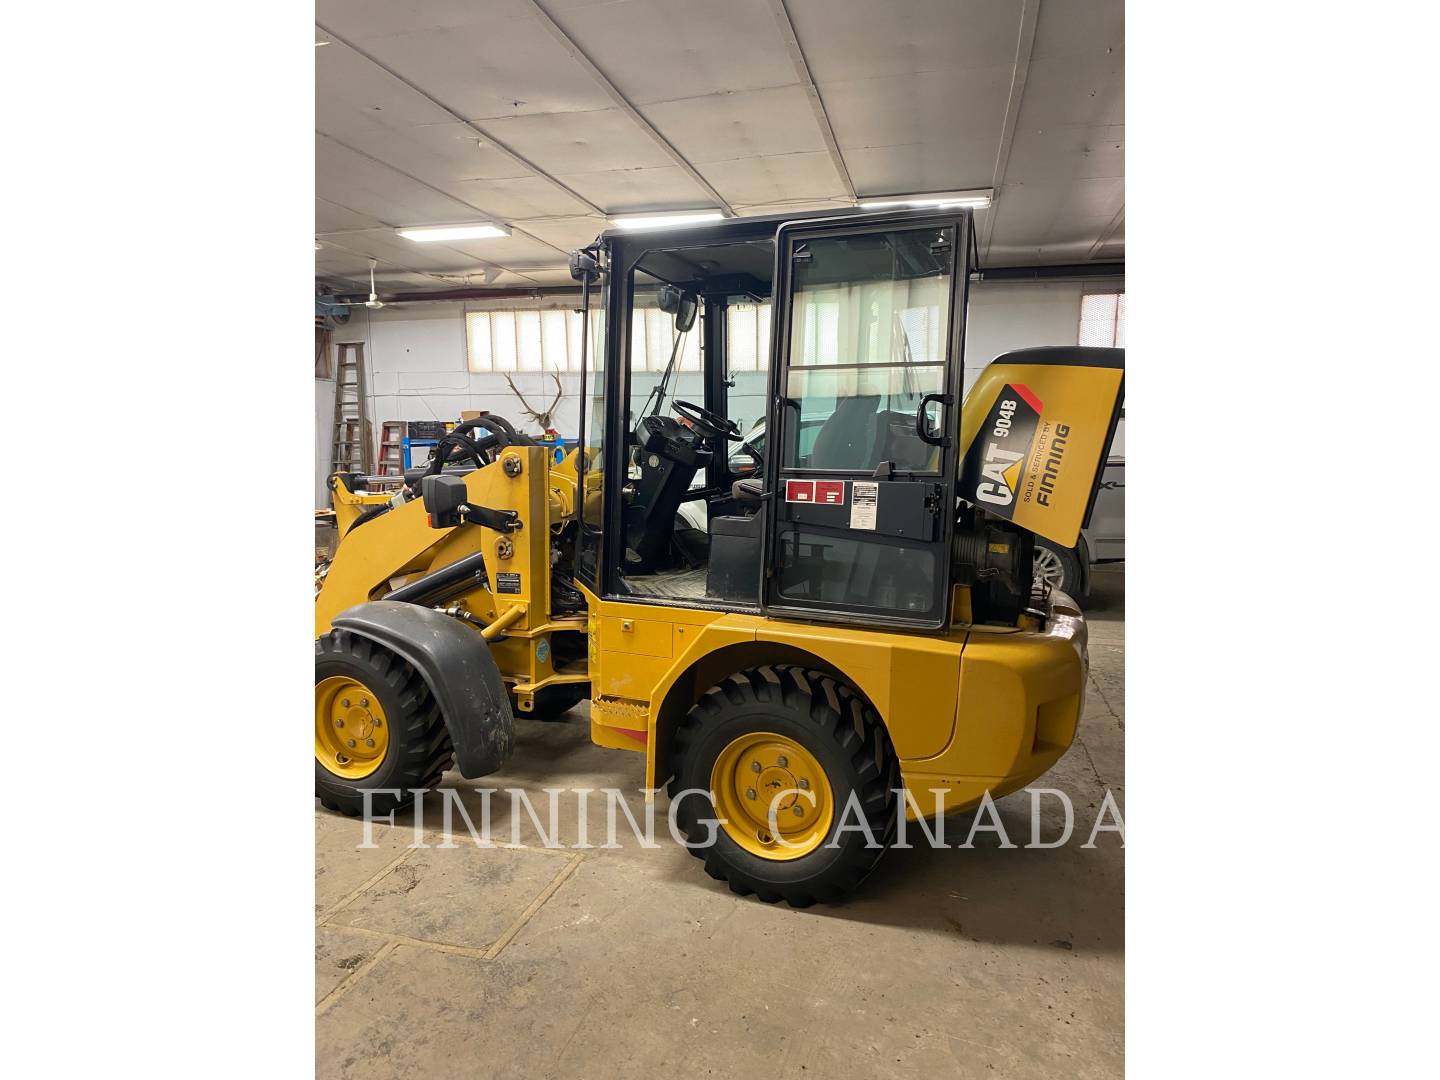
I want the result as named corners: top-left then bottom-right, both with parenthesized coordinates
top-left (315, 629), bottom-right (454, 816)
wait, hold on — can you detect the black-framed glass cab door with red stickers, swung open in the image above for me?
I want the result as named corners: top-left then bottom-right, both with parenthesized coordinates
top-left (765, 215), bottom-right (969, 626)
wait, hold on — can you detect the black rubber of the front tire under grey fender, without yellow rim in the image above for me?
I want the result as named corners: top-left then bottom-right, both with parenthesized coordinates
top-left (315, 629), bottom-right (455, 818)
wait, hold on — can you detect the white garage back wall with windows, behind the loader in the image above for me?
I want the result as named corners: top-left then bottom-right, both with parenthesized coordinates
top-left (315, 278), bottom-right (1125, 507)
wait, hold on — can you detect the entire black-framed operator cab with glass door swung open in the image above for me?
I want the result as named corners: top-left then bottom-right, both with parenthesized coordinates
top-left (576, 215), bottom-right (968, 626)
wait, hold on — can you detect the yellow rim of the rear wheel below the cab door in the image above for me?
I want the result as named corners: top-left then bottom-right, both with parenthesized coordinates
top-left (710, 732), bottom-right (835, 861)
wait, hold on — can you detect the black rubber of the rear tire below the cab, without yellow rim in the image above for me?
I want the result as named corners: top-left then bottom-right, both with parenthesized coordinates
top-left (668, 665), bottom-right (900, 907)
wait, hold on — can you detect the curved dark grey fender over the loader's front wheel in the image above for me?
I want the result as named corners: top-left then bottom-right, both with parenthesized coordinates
top-left (331, 600), bottom-right (516, 779)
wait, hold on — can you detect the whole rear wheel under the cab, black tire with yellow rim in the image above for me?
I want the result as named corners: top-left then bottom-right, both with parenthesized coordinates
top-left (670, 665), bottom-right (899, 907)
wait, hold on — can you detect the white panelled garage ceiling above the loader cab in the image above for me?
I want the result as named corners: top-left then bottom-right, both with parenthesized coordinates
top-left (315, 0), bottom-right (1125, 288)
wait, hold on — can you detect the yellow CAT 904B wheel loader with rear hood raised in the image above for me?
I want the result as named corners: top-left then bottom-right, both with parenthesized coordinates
top-left (315, 209), bottom-right (1123, 906)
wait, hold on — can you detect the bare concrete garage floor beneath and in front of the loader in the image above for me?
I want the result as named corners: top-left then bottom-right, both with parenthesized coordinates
top-left (315, 567), bottom-right (1125, 1080)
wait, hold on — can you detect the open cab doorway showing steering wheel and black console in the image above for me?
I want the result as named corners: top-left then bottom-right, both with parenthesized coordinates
top-left (582, 230), bottom-right (775, 609)
